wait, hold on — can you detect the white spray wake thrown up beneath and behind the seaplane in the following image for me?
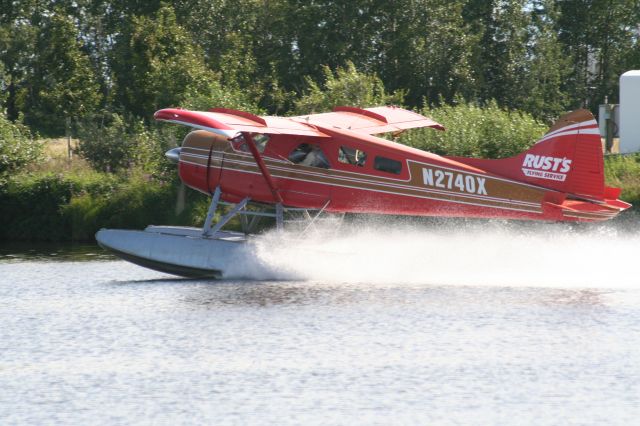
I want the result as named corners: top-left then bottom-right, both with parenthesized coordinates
top-left (225, 215), bottom-right (640, 288)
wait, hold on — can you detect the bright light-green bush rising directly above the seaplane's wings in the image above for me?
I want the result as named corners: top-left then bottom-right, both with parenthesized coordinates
top-left (295, 62), bottom-right (402, 114)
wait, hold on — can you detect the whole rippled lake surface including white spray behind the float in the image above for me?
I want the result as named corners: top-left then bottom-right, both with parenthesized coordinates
top-left (0, 223), bottom-right (640, 425)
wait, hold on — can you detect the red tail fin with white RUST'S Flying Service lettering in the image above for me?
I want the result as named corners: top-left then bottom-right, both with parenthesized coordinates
top-left (456, 110), bottom-right (608, 200)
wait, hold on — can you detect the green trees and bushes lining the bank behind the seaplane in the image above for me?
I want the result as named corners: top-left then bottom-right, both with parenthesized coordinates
top-left (0, 0), bottom-right (640, 243)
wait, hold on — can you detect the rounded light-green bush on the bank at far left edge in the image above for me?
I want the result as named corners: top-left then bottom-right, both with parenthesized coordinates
top-left (0, 113), bottom-right (42, 182)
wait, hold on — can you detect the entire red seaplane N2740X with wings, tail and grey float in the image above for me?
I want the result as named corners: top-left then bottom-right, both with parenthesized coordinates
top-left (96, 106), bottom-right (630, 278)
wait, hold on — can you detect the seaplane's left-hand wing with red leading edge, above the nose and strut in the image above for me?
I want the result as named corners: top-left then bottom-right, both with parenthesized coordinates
top-left (153, 108), bottom-right (329, 138)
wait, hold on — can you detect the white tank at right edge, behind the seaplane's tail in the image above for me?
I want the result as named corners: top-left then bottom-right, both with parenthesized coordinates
top-left (620, 70), bottom-right (640, 153)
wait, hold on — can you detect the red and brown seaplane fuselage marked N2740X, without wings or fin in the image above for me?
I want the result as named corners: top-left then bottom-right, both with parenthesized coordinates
top-left (179, 129), bottom-right (619, 221)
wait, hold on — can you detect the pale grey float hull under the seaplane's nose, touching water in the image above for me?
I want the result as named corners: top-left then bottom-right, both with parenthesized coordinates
top-left (96, 226), bottom-right (248, 278)
